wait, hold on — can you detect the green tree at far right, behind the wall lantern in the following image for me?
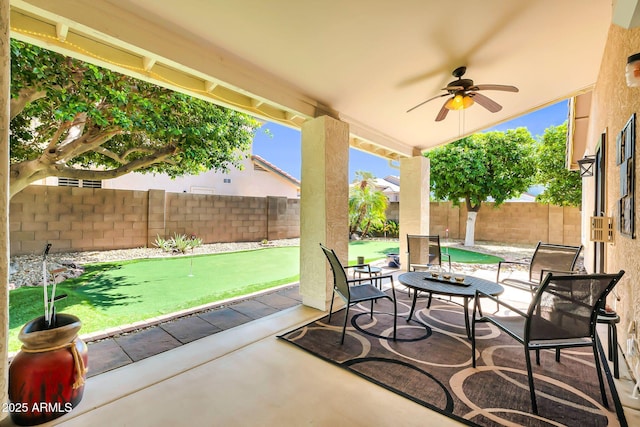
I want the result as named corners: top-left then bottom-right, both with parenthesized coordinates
top-left (535, 122), bottom-right (582, 207)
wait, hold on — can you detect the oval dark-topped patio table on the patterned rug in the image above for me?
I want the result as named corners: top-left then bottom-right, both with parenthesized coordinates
top-left (398, 271), bottom-right (504, 339)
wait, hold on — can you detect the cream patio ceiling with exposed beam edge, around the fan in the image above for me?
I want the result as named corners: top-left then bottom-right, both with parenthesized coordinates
top-left (11, 0), bottom-right (612, 159)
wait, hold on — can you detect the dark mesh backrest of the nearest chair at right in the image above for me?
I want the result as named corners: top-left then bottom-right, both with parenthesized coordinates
top-left (525, 271), bottom-right (624, 341)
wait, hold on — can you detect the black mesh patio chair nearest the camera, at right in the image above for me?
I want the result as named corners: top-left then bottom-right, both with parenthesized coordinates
top-left (471, 270), bottom-right (624, 414)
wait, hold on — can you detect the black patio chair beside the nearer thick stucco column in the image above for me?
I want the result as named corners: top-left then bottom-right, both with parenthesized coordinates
top-left (320, 243), bottom-right (398, 344)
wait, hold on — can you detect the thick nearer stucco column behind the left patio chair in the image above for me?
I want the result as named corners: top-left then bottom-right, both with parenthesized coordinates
top-left (300, 116), bottom-right (349, 311)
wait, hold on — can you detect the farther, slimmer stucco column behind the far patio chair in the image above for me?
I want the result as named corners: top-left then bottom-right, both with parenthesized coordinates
top-left (400, 156), bottom-right (430, 268)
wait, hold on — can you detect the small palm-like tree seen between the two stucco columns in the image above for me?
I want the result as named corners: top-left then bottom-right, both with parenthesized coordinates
top-left (349, 171), bottom-right (389, 236)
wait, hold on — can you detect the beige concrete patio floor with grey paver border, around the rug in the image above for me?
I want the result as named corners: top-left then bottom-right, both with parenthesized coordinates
top-left (0, 262), bottom-right (640, 427)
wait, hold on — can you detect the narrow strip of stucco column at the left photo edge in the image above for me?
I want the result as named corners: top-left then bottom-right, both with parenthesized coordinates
top-left (0, 1), bottom-right (11, 419)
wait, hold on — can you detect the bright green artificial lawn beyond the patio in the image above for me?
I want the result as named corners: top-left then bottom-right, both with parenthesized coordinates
top-left (9, 240), bottom-right (500, 351)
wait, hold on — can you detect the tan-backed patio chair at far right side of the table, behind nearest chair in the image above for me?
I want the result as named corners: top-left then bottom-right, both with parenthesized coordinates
top-left (496, 242), bottom-right (582, 293)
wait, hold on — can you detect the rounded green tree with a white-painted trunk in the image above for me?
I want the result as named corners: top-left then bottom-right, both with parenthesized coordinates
top-left (425, 128), bottom-right (535, 246)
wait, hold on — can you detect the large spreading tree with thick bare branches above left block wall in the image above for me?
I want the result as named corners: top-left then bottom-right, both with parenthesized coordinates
top-left (10, 40), bottom-right (259, 196)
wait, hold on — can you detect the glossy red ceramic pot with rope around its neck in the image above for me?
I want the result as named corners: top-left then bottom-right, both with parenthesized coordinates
top-left (8, 313), bottom-right (88, 426)
